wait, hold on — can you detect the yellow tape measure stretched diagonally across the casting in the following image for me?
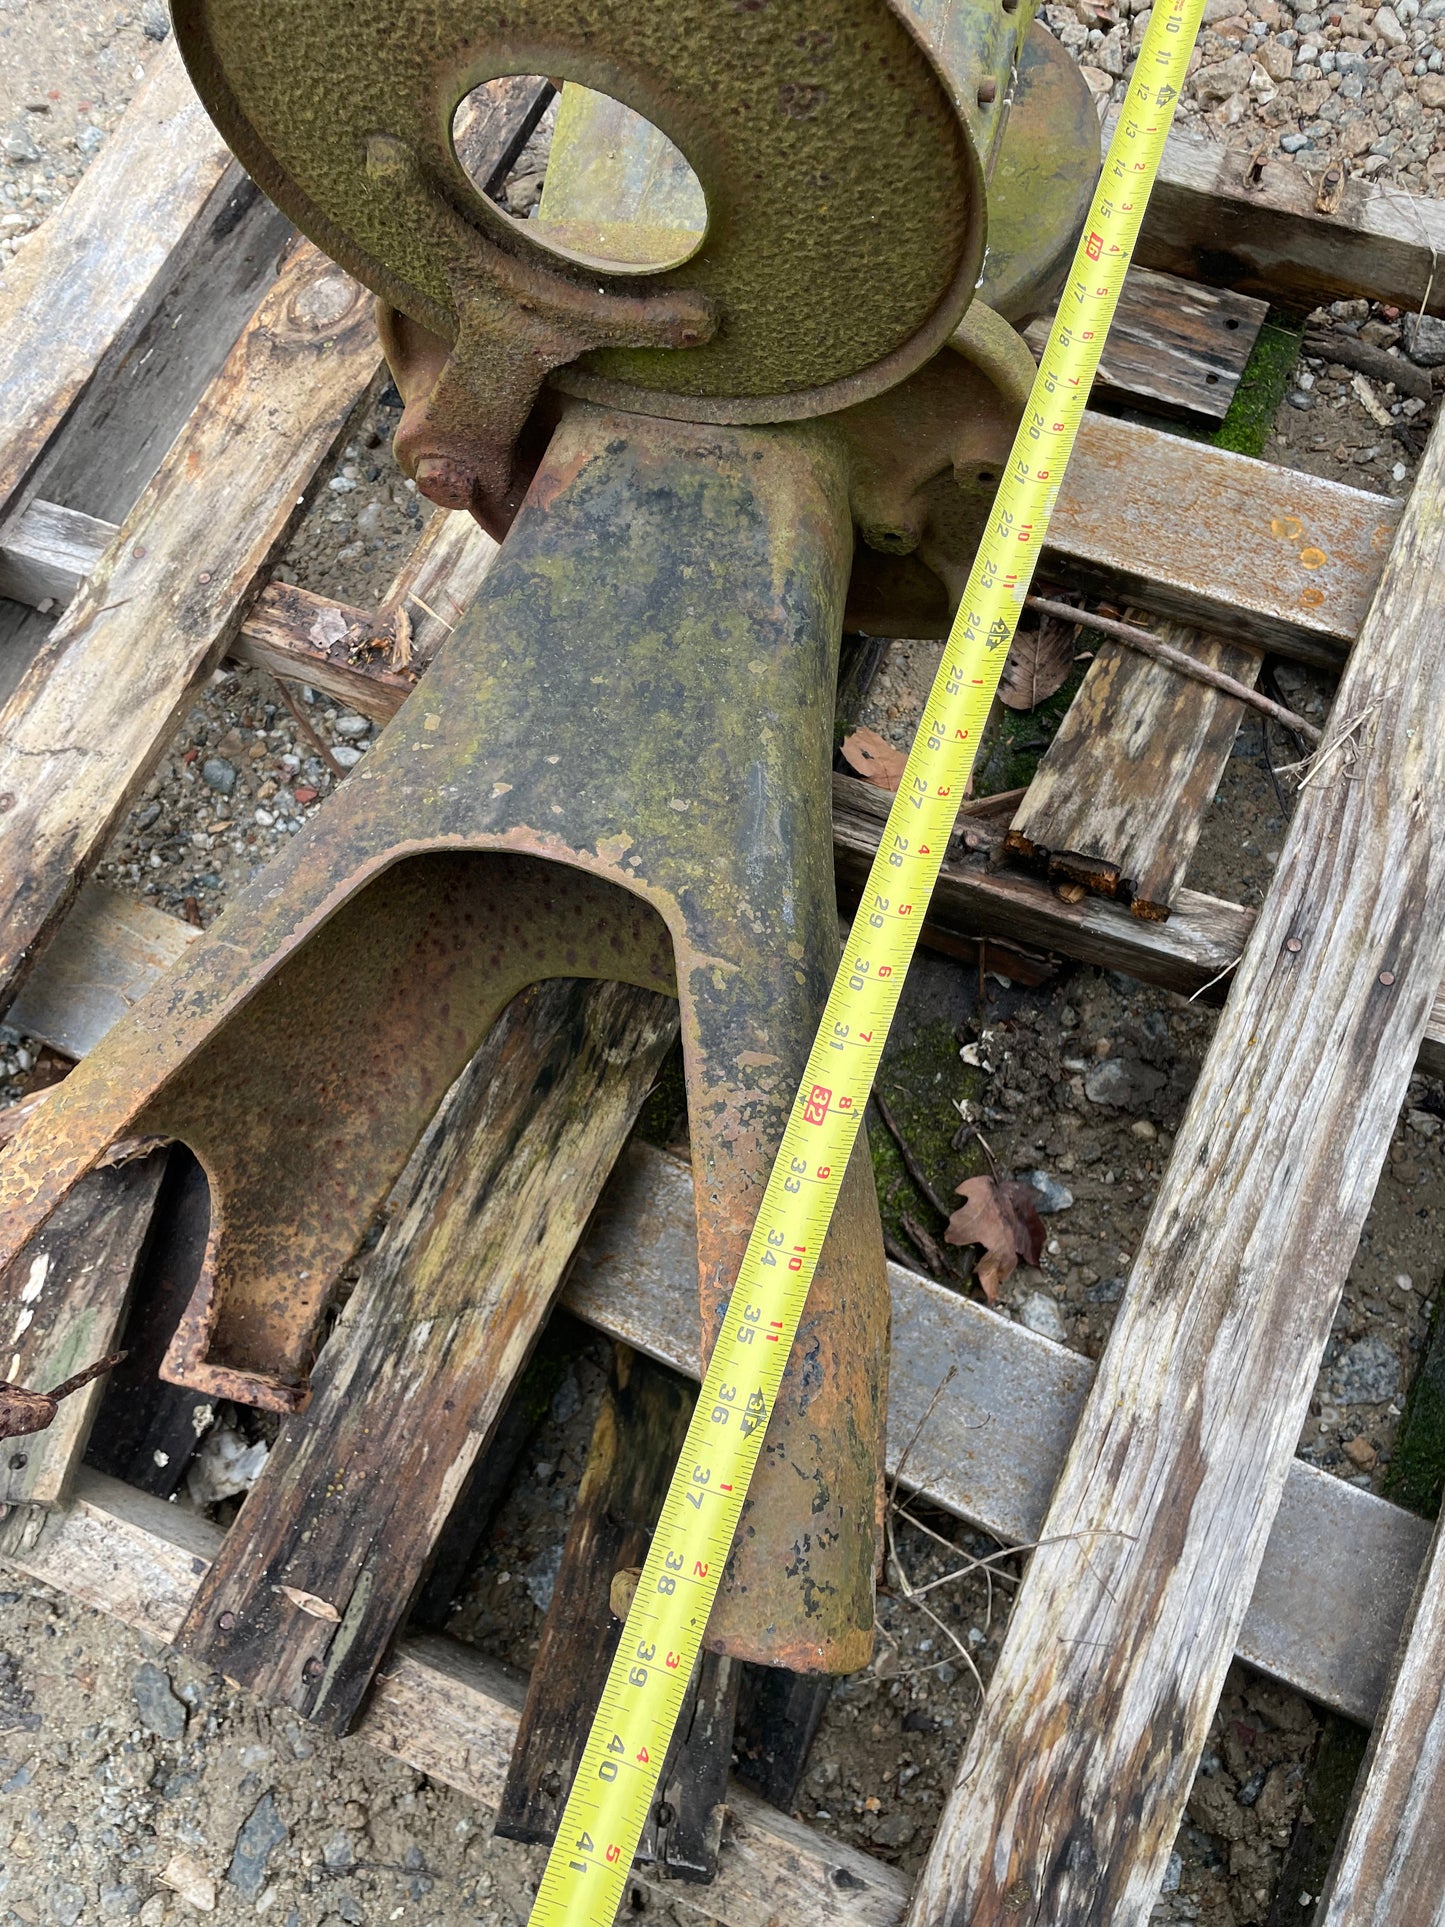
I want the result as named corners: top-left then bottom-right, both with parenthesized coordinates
top-left (530, 0), bottom-right (1204, 1927)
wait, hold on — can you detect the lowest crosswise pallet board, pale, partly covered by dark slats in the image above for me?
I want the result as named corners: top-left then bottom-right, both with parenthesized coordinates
top-left (10, 1470), bottom-right (907, 1927)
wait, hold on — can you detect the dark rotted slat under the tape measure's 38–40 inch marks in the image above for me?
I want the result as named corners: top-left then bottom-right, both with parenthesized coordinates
top-left (497, 1345), bottom-right (740, 1881)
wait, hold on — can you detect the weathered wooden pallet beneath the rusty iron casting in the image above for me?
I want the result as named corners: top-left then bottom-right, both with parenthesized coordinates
top-left (0, 44), bottom-right (1445, 1927)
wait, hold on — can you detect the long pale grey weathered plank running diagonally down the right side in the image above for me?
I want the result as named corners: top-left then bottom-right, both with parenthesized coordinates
top-left (909, 410), bottom-right (1445, 1927)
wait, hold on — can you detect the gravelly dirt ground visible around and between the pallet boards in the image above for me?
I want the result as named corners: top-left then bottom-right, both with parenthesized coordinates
top-left (0, 0), bottom-right (1445, 1927)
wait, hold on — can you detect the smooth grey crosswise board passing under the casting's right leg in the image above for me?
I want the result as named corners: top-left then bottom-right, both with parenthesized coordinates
top-left (563, 1145), bottom-right (1430, 1721)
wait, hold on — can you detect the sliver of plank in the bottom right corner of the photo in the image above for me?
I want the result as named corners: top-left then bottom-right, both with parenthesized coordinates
top-left (1318, 1530), bottom-right (1445, 1927)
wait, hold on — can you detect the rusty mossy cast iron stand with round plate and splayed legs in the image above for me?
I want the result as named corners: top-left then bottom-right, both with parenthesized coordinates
top-left (0, 0), bottom-right (1098, 1671)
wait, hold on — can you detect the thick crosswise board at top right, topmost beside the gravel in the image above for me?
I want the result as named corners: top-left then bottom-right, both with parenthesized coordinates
top-left (1132, 116), bottom-right (1445, 314)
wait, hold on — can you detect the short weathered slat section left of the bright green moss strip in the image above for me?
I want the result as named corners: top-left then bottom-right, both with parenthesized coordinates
top-left (1023, 268), bottom-right (1270, 422)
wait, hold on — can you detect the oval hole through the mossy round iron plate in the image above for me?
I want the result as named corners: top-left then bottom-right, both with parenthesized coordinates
top-left (451, 75), bottom-right (707, 274)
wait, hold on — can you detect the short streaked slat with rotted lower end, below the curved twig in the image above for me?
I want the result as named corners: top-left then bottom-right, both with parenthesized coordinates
top-left (1004, 624), bottom-right (1264, 923)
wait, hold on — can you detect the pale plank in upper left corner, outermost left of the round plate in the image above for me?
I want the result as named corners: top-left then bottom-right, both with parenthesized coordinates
top-left (0, 39), bottom-right (231, 507)
